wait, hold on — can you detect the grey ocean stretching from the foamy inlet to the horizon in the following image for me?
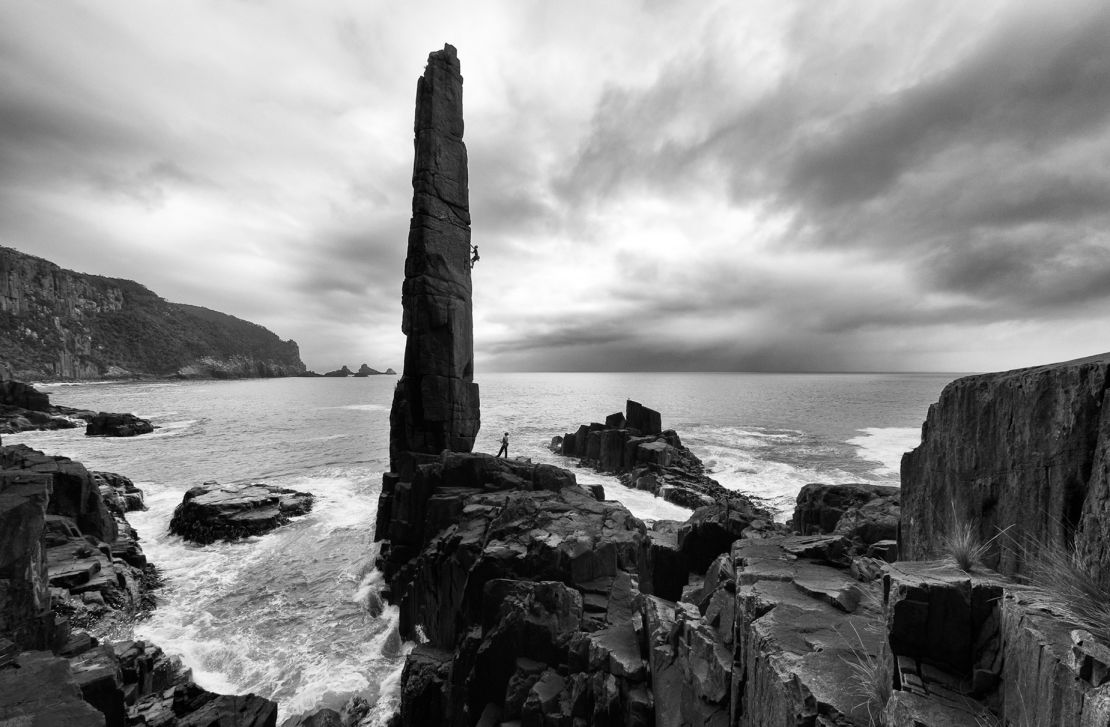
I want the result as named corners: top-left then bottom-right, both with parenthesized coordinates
top-left (4, 373), bottom-right (956, 724)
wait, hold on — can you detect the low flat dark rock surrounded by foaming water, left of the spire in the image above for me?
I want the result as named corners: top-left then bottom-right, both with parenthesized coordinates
top-left (170, 482), bottom-right (314, 545)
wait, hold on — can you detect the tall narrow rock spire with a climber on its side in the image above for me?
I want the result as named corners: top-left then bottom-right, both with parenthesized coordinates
top-left (390, 46), bottom-right (480, 472)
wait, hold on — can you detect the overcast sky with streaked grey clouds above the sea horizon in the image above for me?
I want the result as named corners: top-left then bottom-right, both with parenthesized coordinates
top-left (0, 0), bottom-right (1110, 380)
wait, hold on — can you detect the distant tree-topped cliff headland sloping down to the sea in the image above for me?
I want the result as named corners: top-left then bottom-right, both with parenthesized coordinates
top-left (0, 246), bottom-right (304, 381)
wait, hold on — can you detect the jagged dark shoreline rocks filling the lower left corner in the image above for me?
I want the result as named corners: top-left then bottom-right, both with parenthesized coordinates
top-left (0, 445), bottom-right (278, 727)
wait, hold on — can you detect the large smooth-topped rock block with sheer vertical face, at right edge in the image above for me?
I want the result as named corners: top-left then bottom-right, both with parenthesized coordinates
top-left (900, 354), bottom-right (1110, 588)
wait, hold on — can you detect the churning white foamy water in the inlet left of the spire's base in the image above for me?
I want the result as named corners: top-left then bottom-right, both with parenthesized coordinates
top-left (124, 467), bottom-right (406, 719)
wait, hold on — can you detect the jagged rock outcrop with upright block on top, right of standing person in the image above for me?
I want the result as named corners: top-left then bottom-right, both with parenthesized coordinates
top-left (552, 400), bottom-right (754, 512)
